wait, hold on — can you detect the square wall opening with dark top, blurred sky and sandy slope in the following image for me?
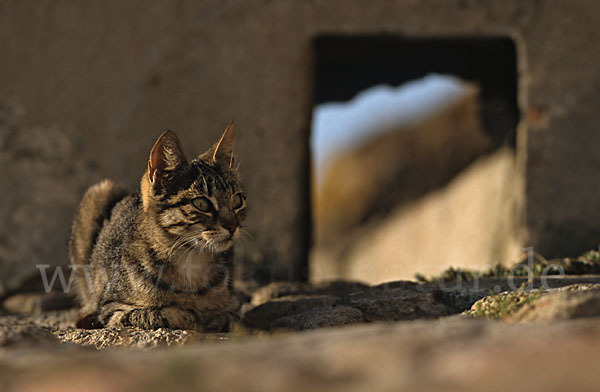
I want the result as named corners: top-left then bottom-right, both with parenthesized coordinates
top-left (310, 35), bottom-right (521, 283)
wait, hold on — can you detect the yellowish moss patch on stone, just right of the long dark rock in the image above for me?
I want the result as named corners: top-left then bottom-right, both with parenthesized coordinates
top-left (463, 286), bottom-right (543, 320)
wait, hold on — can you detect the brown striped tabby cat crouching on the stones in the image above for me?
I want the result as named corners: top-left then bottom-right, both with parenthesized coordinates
top-left (69, 122), bottom-right (246, 331)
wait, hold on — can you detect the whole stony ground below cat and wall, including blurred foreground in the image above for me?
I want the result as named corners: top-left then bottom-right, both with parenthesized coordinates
top-left (0, 277), bottom-right (600, 392)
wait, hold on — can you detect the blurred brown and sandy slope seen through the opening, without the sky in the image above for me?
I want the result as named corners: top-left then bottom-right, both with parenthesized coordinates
top-left (310, 85), bottom-right (520, 283)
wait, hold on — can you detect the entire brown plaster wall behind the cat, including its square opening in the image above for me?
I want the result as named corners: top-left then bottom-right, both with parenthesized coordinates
top-left (0, 0), bottom-right (600, 291)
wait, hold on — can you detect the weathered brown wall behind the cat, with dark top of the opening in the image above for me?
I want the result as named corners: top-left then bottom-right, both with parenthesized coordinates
top-left (0, 0), bottom-right (600, 284)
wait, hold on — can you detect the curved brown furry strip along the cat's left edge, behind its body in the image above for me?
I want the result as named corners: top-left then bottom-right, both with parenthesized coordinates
top-left (69, 180), bottom-right (128, 301)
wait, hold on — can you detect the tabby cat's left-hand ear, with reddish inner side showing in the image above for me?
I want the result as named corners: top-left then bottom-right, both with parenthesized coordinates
top-left (148, 130), bottom-right (187, 185)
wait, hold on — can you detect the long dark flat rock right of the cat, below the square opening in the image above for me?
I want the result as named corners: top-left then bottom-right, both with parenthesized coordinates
top-left (242, 282), bottom-right (472, 331)
